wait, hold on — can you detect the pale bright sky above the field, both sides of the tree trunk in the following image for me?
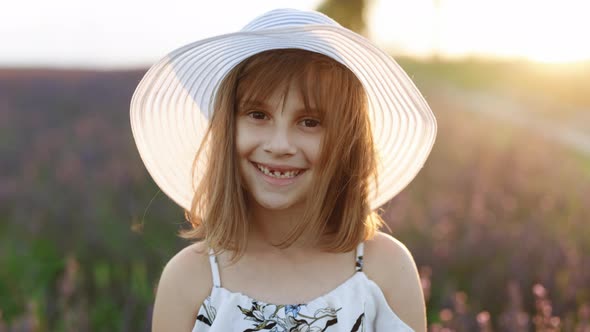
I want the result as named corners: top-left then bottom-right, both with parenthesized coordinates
top-left (0, 0), bottom-right (590, 69)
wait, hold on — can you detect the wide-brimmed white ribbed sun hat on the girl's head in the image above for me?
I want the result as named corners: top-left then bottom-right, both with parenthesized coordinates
top-left (130, 9), bottom-right (437, 210)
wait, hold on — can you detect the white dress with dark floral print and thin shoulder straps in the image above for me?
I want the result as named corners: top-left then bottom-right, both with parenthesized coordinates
top-left (192, 242), bottom-right (413, 332)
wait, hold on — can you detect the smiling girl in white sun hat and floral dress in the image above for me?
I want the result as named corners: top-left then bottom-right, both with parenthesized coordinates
top-left (131, 9), bottom-right (436, 332)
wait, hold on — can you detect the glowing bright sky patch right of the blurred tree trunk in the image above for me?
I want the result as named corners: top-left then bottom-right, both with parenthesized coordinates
top-left (369, 0), bottom-right (590, 63)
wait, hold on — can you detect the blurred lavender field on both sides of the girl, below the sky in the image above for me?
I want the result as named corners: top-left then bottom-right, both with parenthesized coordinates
top-left (0, 62), bottom-right (590, 332)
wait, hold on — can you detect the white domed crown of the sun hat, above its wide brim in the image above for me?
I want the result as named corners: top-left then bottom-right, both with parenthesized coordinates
top-left (241, 8), bottom-right (340, 31)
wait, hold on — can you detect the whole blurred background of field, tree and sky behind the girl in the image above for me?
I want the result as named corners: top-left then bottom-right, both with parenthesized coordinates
top-left (0, 0), bottom-right (590, 332)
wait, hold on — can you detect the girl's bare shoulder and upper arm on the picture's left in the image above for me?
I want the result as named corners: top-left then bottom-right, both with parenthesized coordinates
top-left (152, 242), bottom-right (213, 332)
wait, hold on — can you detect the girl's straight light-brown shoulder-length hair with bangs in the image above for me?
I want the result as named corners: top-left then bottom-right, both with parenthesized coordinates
top-left (180, 49), bottom-right (383, 259)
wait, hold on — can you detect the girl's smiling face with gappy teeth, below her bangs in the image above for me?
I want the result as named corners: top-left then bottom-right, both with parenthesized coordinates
top-left (236, 83), bottom-right (324, 210)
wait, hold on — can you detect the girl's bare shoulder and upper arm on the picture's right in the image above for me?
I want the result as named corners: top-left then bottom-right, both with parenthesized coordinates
top-left (363, 232), bottom-right (426, 331)
